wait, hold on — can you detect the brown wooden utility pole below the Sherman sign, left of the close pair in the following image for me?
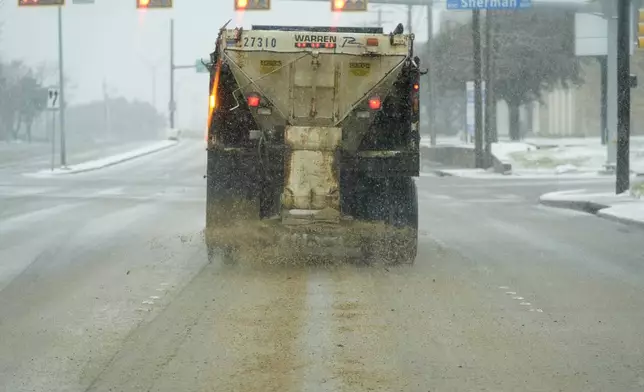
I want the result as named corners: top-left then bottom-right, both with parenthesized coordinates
top-left (472, 9), bottom-right (484, 169)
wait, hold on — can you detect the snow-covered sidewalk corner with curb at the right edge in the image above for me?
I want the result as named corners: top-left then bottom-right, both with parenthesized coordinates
top-left (539, 184), bottom-right (644, 228)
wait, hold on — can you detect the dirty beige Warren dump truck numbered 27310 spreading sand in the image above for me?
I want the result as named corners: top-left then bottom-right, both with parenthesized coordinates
top-left (205, 25), bottom-right (421, 264)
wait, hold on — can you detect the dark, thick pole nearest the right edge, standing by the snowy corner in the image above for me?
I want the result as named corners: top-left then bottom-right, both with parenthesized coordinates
top-left (609, 0), bottom-right (632, 194)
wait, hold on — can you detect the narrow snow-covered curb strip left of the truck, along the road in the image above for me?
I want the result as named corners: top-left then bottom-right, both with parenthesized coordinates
top-left (24, 140), bottom-right (179, 177)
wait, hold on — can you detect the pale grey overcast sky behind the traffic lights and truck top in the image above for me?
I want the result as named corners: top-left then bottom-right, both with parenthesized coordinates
top-left (0, 0), bottom-right (438, 127)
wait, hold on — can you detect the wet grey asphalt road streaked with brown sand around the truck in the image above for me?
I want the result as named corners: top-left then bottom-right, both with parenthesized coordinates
top-left (0, 142), bottom-right (644, 392)
